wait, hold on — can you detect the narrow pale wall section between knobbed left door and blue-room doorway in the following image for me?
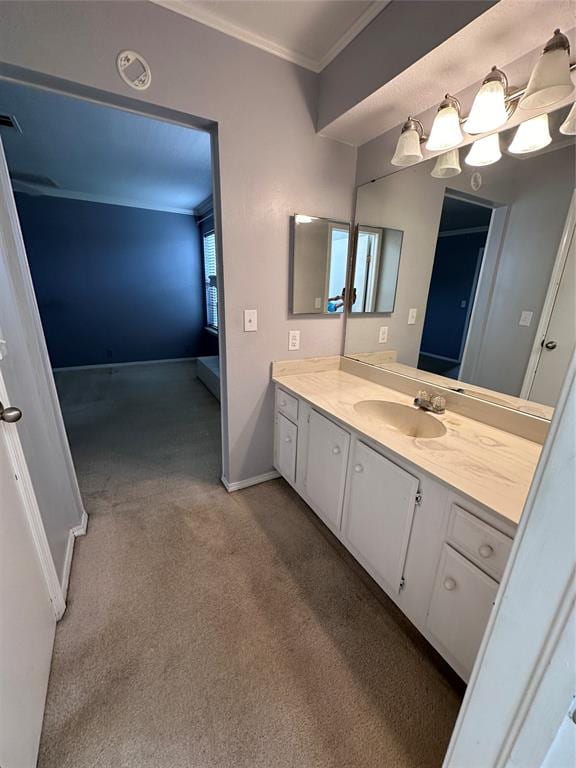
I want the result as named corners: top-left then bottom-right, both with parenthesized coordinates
top-left (0, 136), bottom-right (83, 584)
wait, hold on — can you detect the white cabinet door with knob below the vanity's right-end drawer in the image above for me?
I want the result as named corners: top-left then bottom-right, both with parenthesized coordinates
top-left (427, 544), bottom-right (498, 680)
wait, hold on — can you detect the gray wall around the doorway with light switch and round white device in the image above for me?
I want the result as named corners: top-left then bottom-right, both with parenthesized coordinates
top-left (0, 0), bottom-right (355, 482)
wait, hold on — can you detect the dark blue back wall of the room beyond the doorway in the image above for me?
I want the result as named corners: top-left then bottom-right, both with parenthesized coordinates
top-left (16, 193), bottom-right (214, 367)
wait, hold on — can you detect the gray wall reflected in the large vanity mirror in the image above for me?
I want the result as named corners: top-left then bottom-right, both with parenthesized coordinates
top-left (345, 142), bottom-right (575, 395)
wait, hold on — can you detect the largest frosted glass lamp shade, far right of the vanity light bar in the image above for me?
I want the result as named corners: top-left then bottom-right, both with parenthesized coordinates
top-left (518, 29), bottom-right (574, 109)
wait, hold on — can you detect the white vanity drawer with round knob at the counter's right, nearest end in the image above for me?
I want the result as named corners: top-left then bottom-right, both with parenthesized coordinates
top-left (448, 504), bottom-right (512, 581)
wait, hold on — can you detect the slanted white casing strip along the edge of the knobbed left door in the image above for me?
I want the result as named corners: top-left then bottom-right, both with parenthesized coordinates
top-left (0, 374), bottom-right (66, 621)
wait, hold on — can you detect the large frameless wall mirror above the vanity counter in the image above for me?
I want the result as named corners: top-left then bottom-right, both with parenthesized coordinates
top-left (345, 104), bottom-right (576, 418)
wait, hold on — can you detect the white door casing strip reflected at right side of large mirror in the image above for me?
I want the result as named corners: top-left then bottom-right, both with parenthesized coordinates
top-left (520, 190), bottom-right (576, 400)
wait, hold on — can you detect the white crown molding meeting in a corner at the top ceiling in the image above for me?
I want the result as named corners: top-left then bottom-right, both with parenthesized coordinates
top-left (151, 0), bottom-right (391, 73)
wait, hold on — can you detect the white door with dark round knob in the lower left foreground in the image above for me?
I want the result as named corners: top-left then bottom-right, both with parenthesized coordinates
top-left (0, 373), bottom-right (56, 768)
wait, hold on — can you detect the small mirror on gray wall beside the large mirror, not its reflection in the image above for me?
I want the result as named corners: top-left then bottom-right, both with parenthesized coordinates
top-left (290, 213), bottom-right (350, 315)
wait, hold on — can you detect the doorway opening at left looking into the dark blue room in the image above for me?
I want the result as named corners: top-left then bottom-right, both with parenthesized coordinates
top-left (0, 79), bottom-right (222, 528)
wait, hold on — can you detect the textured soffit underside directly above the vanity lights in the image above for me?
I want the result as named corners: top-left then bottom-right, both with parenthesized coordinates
top-left (321, 0), bottom-right (576, 146)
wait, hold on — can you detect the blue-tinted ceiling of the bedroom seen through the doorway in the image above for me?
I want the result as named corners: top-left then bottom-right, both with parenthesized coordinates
top-left (0, 79), bottom-right (212, 213)
